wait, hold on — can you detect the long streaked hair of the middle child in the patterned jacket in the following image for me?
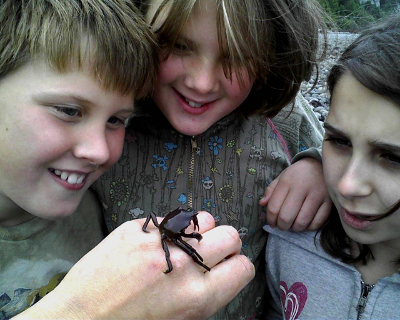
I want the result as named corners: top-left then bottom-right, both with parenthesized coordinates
top-left (141, 0), bottom-right (326, 116)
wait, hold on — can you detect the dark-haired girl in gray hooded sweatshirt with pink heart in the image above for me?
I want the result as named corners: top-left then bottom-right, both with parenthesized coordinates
top-left (266, 15), bottom-right (400, 319)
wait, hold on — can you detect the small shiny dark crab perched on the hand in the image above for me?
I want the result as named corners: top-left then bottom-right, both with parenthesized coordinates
top-left (142, 207), bottom-right (210, 273)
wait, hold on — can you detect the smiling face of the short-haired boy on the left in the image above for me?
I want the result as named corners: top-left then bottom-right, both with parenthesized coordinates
top-left (0, 60), bottom-right (134, 226)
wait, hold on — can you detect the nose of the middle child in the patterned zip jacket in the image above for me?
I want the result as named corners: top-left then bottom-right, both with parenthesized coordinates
top-left (185, 58), bottom-right (220, 94)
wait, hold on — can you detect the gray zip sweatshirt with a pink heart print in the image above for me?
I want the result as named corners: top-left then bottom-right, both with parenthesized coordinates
top-left (264, 226), bottom-right (400, 320)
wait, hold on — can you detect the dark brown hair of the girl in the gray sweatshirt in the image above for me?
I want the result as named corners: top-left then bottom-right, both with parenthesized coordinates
top-left (318, 14), bottom-right (400, 264)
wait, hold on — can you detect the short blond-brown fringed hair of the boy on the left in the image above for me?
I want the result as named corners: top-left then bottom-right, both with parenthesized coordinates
top-left (0, 0), bottom-right (158, 98)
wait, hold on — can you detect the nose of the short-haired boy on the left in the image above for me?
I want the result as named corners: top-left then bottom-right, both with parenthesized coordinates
top-left (73, 126), bottom-right (110, 165)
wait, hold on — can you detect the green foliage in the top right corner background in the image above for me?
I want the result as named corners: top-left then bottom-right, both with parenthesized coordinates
top-left (318, 0), bottom-right (400, 32)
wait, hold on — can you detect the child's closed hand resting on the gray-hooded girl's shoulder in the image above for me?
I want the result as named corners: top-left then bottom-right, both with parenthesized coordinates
top-left (260, 158), bottom-right (332, 231)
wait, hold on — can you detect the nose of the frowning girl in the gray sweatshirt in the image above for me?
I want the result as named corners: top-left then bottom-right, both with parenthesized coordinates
top-left (338, 158), bottom-right (373, 199)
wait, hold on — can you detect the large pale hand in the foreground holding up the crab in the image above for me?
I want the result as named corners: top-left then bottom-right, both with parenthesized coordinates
top-left (16, 212), bottom-right (255, 319)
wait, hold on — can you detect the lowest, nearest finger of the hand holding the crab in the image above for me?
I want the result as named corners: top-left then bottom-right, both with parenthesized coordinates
top-left (204, 255), bottom-right (255, 318)
